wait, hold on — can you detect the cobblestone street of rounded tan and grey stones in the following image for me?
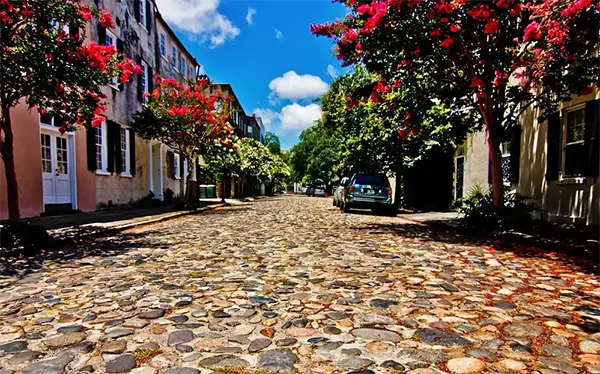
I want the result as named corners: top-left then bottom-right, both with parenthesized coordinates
top-left (0, 196), bottom-right (600, 374)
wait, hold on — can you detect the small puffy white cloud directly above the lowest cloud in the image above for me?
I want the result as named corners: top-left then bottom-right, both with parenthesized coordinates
top-left (269, 70), bottom-right (329, 101)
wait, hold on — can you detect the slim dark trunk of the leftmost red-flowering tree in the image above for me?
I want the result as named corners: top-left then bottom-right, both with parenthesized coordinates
top-left (0, 108), bottom-right (21, 224)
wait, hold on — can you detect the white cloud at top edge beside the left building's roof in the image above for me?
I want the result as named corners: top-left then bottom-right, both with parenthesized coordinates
top-left (156, 0), bottom-right (240, 48)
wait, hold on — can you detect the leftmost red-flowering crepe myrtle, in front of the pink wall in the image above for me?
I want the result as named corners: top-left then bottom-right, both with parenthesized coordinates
top-left (0, 0), bottom-right (141, 223)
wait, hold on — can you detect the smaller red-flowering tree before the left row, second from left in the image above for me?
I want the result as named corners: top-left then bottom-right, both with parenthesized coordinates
top-left (131, 74), bottom-right (235, 201)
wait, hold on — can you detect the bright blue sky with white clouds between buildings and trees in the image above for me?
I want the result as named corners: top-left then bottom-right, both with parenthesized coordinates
top-left (156, 0), bottom-right (345, 149)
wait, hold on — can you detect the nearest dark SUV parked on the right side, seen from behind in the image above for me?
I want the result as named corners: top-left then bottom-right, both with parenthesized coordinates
top-left (340, 174), bottom-right (398, 216)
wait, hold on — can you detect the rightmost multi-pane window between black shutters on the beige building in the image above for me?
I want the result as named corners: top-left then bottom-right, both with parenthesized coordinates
top-left (563, 108), bottom-right (585, 177)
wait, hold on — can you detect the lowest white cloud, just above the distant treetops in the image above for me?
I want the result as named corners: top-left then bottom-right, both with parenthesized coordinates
top-left (254, 103), bottom-right (321, 134)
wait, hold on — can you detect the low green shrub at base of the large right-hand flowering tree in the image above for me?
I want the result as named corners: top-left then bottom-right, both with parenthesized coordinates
top-left (459, 186), bottom-right (536, 231)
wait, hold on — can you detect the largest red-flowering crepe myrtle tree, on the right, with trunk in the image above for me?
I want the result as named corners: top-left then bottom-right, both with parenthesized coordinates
top-left (311, 0), bottom-right (600, 206)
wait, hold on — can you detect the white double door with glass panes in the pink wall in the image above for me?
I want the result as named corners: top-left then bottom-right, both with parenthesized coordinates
top-left (40, 133), bottom-right (73, 204)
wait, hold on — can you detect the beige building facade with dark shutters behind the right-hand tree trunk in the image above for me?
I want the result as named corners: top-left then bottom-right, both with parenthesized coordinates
top-left (455, 93), bottom-right (600, 225)
